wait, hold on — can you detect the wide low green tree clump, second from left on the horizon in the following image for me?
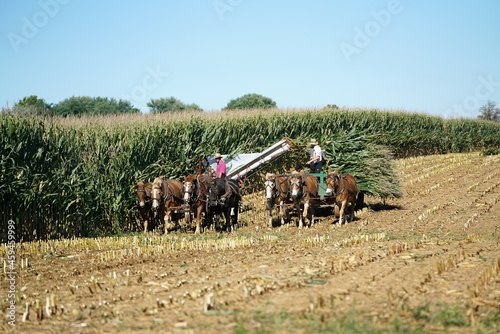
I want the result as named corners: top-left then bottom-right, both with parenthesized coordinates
top-left (52, 96), bottom-right (139, 116)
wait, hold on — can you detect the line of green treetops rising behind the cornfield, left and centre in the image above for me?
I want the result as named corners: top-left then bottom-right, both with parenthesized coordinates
top-left (2, 94), bottom-right (276, 116)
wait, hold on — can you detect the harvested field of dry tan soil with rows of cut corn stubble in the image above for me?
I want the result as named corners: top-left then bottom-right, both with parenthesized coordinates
top-left (0, 153), bottom-right (500, 333)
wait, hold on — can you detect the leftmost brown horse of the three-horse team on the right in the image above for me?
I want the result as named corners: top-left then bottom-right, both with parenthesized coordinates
top-left (264, 173), bottom-right (292, 227)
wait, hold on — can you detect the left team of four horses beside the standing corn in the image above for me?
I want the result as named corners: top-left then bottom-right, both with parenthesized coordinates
top-left (135, 173), bottom-right (241, 234)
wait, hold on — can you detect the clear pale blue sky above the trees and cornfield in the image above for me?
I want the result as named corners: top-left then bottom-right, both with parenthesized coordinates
top-left (0, 0), bottom-right (500, 118)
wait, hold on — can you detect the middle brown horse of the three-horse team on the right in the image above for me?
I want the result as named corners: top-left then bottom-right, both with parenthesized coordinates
top-left (288, 170), bottom-right (319, 228)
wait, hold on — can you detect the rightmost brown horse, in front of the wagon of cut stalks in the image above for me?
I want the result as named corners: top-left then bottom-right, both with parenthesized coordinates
top-left (325, 169), bottom-right (359, 225)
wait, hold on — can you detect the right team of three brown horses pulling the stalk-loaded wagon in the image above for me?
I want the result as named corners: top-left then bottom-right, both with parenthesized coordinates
top-left (264, 169), bottom-right (360, 228)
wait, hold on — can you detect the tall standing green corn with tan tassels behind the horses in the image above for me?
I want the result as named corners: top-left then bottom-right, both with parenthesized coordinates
top-left (0, 110), bottom-right (500, 242)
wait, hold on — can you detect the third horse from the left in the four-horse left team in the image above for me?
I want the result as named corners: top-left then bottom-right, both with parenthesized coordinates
top-left (183, 174), bottom-right (212, 234)
